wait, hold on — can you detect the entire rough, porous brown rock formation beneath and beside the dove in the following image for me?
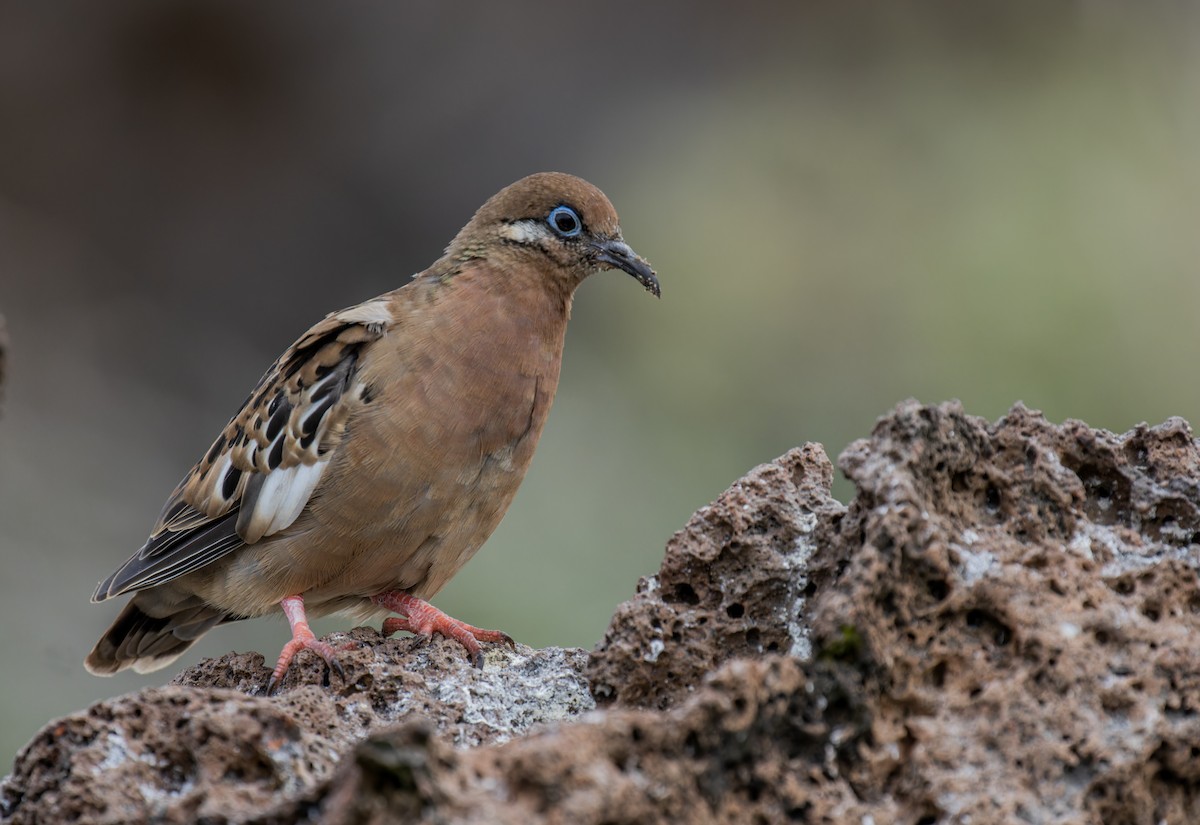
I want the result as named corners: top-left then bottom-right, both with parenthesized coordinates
top-left (7, 402), bottom-right (1200, 825)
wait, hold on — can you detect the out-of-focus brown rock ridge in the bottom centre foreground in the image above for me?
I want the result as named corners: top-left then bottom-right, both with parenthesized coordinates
top-left (270, 654), bottom-right (895, 825)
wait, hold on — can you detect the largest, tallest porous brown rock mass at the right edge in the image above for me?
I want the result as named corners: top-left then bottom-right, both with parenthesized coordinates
top-left (809, 402), bottom-right (1200, 824)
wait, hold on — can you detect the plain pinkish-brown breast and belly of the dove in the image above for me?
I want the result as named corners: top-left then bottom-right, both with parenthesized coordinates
top-left (297, 280), bottom-right (565, 596)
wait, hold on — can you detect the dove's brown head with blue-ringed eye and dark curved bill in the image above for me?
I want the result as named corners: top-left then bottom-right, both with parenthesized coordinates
top-left (446, 171), bottom-right (660, 296)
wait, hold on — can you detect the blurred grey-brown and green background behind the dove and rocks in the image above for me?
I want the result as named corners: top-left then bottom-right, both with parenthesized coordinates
top-left (0, 0), bottom-right (1200, 770)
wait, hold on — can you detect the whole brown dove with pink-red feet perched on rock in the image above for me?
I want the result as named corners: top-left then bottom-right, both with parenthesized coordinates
top-left (86, 173), bottom-right (659, 684)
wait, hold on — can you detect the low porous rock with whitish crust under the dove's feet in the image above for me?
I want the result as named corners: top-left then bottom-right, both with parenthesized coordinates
top-left (0, 627), bottom-right (594, 825)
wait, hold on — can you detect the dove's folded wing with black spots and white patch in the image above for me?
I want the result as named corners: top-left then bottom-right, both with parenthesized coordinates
top-left (92, 299), bottom-right (394, 602)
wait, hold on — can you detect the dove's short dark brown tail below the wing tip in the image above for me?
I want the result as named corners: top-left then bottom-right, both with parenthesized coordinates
top-left (84, 596), bottom-right (230, 676)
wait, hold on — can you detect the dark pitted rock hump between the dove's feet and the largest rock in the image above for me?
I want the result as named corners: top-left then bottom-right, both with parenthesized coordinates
top-left (588, 444), bottom-right (846, 710)
